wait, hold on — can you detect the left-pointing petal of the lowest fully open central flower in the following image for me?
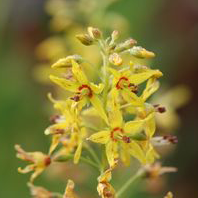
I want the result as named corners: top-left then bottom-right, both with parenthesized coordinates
top-left (87, 131), bottom-right (110, 144)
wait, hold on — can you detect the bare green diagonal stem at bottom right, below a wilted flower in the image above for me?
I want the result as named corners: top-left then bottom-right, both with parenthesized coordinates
top-left (116, 169), bottom-right (145, 198)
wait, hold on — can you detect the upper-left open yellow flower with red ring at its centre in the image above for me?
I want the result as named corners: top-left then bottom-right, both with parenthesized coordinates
top-left (50, 61), bottom-right (108, 123)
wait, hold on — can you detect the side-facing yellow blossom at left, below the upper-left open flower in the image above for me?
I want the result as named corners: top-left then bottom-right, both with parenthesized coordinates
top-left (45, 95), bottom-right (86, 163)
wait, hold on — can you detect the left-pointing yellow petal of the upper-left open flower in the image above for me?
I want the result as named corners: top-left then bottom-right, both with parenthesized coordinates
top-left (50, 75), bottom-right (79, 92)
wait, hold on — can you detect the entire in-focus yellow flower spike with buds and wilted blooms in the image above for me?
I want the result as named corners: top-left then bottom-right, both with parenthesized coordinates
top-left (16, 27), bottom-right (177, 198)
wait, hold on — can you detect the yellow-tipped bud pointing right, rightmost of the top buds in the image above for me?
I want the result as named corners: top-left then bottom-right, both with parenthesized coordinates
top-left (130, 46), bottom-right (155, 58)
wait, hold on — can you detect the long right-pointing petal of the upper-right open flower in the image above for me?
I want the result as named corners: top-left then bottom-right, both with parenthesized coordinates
top-left (129, 70), bottom-right (162, 85)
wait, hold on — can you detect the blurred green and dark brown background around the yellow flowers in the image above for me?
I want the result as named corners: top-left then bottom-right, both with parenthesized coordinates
top-left (0, 0), bottom-right (198, 198)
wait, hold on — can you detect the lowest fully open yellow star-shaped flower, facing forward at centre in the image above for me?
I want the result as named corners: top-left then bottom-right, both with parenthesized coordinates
top-left (88, 104), bottom-right (144, 166)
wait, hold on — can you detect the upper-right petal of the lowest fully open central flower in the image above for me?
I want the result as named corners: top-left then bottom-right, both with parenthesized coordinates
top-left (124, 120), bottom-right (144, 134)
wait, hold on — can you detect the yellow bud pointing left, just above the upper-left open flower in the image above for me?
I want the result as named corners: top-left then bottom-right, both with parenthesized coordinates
top-left (52, 54), bottom-right (83, 68)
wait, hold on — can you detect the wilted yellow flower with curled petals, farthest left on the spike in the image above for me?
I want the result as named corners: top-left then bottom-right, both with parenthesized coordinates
top-left (15, 145), bottom-right (51, 182)
